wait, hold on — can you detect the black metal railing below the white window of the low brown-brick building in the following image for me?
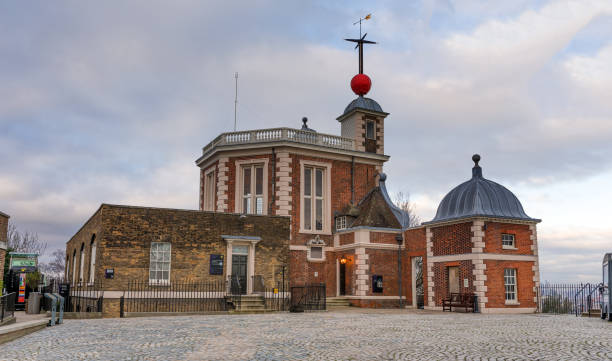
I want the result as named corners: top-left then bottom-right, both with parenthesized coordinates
top-left (120, 280), bottom-right (227, 314)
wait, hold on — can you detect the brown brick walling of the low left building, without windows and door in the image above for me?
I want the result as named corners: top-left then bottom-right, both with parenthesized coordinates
top-left (66, 204), bottom-right (289, 290)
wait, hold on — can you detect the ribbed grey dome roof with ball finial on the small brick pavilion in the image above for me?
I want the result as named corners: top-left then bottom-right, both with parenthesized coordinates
top-left (423, 154), bottom-right (540, 224)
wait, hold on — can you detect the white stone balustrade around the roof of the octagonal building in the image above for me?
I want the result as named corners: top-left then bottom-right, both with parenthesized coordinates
top-left (202, 128), bottom-right (355, 156)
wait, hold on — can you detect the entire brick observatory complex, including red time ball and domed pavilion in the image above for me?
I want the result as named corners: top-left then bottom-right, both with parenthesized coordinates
top-left (66, 32), bottom-right (539, 312)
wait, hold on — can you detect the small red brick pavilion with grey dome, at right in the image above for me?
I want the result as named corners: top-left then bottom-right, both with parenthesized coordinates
top-left (406, 155), bottom-right (540, 313)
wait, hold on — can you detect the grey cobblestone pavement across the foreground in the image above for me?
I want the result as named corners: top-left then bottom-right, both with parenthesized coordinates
top-left (0, 311), bottom-right (612, 360)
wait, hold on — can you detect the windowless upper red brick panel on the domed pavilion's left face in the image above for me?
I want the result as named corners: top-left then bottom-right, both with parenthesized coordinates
top-left (431, 222), bottom-right (472, 256)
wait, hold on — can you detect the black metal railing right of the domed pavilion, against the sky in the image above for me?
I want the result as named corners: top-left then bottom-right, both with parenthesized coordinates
top-left (538, 282), bottom-right (602, 316)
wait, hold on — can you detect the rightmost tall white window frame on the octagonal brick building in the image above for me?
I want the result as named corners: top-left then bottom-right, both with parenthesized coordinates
top-left (300, 160), bottom-right (333, 235)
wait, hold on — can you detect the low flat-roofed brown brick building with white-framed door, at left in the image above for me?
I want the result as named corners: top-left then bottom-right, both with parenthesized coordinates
top-left (66, 204), bottom-right (289, 317)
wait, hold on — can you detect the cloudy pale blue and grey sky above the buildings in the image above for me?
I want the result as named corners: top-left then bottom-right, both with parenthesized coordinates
top-left (0, 0), bottom-right (612, 282)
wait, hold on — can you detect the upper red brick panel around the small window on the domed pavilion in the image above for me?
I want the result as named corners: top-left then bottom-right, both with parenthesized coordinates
top-left (484, 222), bottom-right (533, 254)
